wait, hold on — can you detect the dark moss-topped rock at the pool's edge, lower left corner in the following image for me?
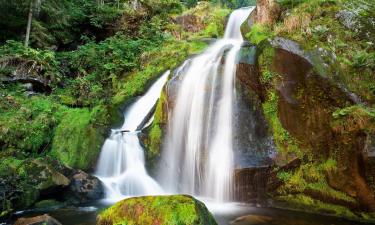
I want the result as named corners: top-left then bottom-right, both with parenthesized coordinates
top-left (0, 159), bottom-right (70, 214)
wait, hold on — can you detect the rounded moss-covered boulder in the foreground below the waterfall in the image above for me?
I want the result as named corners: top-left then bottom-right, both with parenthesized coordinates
top-left (96, 195), bottom-right (217, 225)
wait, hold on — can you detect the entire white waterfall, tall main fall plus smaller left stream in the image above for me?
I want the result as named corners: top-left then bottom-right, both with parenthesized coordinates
top-left (96, 7), bottom-right (254, 202)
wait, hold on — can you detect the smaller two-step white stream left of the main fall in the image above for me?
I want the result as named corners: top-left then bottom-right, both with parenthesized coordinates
top-left (96, 71), bottom-right (170, 202)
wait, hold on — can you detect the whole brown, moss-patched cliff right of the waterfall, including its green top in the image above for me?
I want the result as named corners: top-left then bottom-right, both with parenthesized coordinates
top-left (236, 0), bottom-right (375, 220)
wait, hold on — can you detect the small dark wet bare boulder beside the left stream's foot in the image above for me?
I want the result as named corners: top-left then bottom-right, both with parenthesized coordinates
top-left (65, 170), bottom-right (104, 204)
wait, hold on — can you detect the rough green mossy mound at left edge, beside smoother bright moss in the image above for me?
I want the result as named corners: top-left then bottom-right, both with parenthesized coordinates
top-left (0, 86), bottom-right (63, 155)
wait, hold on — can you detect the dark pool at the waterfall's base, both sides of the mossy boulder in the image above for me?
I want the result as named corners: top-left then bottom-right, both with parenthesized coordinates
top-left (4, 202), bottom-right (369, 225)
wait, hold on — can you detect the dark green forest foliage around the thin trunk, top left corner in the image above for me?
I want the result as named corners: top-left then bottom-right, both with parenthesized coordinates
top-left (0, 0), bottom-right (121, 48)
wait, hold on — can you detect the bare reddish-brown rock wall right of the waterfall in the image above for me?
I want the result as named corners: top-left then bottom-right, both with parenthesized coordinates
top-left (272, 39), bottom-right (375, 211)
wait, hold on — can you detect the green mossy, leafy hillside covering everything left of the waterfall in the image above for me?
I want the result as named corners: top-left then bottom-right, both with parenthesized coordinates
top-left (0, 0), bottom-right (229, 217)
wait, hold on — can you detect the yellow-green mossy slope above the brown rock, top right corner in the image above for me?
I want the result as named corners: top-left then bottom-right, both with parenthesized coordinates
top-left (273, 0), bottom-right (375, 104)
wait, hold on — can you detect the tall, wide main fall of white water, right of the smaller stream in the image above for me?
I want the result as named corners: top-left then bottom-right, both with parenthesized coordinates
top-left (160, 7), bottom-right (254, 202)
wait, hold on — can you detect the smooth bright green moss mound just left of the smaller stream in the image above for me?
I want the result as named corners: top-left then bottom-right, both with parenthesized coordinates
top-left (50, 108), bottom-right (105, 170)
